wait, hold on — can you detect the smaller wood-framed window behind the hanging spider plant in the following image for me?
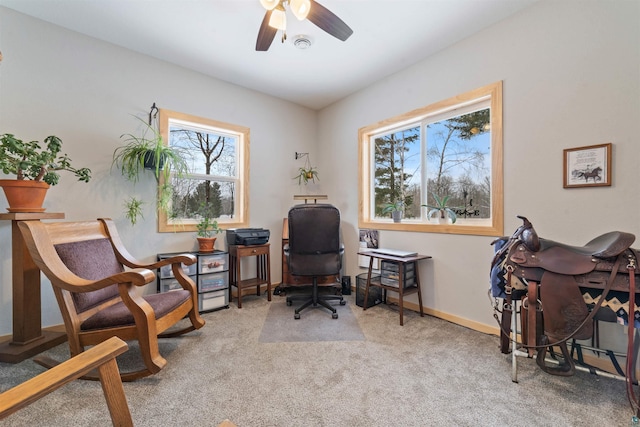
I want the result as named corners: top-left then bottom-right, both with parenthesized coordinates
top-left (159, 110), bottom-right (249, 232)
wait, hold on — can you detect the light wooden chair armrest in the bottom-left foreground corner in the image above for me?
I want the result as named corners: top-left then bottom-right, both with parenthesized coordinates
top-left (0, 337), bottom-right (133, 427)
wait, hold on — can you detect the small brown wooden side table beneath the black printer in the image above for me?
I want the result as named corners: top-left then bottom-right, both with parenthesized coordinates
top-left (229, 243), bottom-right (271, 308)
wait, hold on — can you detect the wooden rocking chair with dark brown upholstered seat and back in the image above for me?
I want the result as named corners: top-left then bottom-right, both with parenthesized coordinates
top-left (19, 219), bottom-right (204, 381)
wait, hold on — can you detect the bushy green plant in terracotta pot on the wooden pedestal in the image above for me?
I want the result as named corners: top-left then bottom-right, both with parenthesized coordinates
top-left (0, 133), bottom-right (91, 212)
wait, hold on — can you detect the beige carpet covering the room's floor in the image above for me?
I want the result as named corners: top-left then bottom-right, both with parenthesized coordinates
top-left (0, 295), bottom-right (632, 427)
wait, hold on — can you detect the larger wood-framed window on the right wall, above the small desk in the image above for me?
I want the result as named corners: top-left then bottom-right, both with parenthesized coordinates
top-left (358, 82), bottom-right (503, 235)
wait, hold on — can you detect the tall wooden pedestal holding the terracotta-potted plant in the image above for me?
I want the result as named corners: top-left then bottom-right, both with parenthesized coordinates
top-left (0, 212), bottom-right (67, 363)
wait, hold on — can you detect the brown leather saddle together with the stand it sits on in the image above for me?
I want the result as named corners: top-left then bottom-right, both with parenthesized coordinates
top-left (491, 217), bottom-right (640, 413)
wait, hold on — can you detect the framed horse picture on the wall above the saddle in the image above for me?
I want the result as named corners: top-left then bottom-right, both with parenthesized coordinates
top-left (563, 142), bottom-right (611, 188)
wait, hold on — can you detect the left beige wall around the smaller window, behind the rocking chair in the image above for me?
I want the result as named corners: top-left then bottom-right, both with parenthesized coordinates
top-left (0, 7), bottom-right (317, 335)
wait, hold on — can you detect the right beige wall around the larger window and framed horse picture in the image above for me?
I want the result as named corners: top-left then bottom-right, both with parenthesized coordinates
top-left (318, 1), bottom-right (640, 327)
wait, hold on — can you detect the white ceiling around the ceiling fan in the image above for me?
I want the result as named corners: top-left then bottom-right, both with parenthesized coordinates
top-left (0, 0), bottom-right (537, 109)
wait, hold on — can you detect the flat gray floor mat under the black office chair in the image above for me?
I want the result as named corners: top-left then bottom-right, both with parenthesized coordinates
top-left (259, 298), bottom-right (364, 343)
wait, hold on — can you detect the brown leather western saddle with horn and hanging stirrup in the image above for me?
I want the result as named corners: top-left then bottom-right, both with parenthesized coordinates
top-left (492, 216), bottom-right (635, 376)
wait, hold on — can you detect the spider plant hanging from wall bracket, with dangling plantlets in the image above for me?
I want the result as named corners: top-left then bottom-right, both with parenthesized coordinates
top-left (111, 117), bottom-right (189, 225)
